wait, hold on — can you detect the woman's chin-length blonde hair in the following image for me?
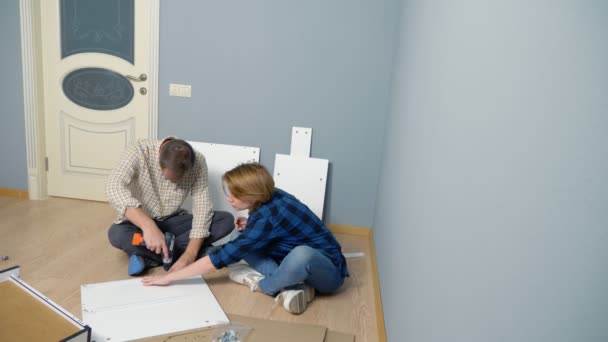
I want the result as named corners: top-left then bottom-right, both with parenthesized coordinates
top-left (222, 163), bottom-right (274, 211)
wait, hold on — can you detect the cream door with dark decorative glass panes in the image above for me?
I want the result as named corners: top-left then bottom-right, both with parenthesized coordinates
top-left (40, 0), bottom-right (151, 200)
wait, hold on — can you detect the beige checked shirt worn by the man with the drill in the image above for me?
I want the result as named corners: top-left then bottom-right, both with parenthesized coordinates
top-left (106, 139), bottom-right (213, 239)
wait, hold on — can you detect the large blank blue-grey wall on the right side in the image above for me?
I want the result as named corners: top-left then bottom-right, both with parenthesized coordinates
top-left (373, 0), bottom-right (608, 342)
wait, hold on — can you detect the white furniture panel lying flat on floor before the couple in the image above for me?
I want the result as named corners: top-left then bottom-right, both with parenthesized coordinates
top-left (80, 276), bottom-right (229, 342)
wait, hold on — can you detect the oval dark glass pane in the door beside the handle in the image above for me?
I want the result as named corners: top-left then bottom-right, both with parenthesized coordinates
top-left (63, 68), bottom-right (134, 110)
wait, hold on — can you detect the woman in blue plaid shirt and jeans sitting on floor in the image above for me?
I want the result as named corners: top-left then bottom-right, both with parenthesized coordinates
top-left (142, 163), bottom-right (349, 314)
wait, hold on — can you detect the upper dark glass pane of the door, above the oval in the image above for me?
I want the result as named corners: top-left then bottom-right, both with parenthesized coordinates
top-left (61, 0), bottom-right (135, 64)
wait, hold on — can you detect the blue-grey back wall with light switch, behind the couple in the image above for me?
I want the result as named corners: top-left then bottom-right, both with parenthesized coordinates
top-left (159, 0), bottom-right (399, 226)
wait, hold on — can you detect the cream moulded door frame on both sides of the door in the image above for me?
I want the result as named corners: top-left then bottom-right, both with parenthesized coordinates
top-left (19, 0), bottom-right (160, 200)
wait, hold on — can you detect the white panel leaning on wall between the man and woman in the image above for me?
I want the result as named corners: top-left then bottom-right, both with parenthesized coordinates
top-left (188, 141), bottom-right (260, 216)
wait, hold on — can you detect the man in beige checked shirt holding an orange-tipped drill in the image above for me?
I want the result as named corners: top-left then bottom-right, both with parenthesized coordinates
top-left (106, 137), bottom-right (234, 275)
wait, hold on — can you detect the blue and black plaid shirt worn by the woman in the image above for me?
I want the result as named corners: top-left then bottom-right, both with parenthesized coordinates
top-left (209, 188), bottom-right (348, 277)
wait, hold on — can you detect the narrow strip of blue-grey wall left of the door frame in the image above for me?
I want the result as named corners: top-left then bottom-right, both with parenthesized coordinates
top-left (0, 0), bottom-right (27, 190)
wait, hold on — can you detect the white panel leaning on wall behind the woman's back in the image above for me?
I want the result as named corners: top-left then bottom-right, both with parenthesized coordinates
top-left (274, 154), bottom-right (329, 219)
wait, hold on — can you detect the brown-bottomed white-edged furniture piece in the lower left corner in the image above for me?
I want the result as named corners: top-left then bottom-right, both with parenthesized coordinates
top-left (0, 266), bottom-right (91, 342)
